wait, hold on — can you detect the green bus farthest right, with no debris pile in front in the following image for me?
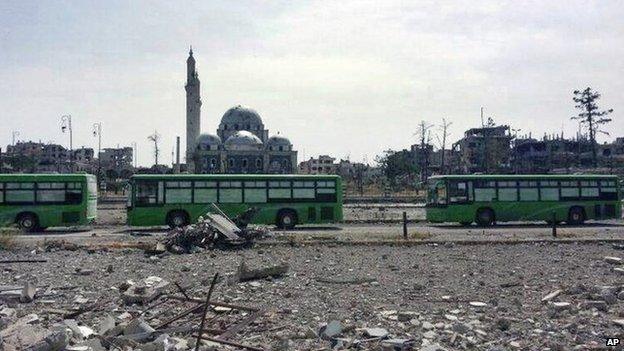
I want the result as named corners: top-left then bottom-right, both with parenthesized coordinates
top-left (425, 175), bottom-right (622, 226)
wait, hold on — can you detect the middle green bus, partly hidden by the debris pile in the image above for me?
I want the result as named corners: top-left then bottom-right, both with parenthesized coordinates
top-left (127, 174), bottom-right (342, 229)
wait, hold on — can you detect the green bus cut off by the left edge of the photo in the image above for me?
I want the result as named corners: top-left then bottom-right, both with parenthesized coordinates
top-left (0, 174), bottom-right (97, 232)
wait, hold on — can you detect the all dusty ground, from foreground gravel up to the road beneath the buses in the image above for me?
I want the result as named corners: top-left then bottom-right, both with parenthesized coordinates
top-left (0, 204), bottom-right (624, 351)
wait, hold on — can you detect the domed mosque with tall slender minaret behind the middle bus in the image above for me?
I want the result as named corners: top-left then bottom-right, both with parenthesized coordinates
top-left (185, 50), bottom-right (297, 174)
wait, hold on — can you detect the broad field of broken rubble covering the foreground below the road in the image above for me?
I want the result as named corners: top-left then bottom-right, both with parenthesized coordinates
top-left (0, 238), bottom-right (624, 351)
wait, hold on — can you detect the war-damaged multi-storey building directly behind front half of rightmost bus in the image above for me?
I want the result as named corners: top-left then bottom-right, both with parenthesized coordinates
top-left (453, 125), bottom-right (513, 173)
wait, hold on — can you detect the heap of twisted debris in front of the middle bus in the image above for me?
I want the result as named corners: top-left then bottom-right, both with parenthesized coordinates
top-left (163, 206), bottom-right (269, 254)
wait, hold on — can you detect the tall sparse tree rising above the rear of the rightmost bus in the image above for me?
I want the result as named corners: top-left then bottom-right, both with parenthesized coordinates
top-left (571, 87), bottom-right (613, 167)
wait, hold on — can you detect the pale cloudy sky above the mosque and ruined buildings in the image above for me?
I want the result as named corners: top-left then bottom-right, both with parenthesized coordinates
top-left (0, 0), bottom-right (624, 165)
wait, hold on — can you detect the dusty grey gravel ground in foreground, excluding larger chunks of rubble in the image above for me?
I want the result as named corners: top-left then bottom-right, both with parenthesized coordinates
top-left (0, 243), bottom-right (624, 350)
